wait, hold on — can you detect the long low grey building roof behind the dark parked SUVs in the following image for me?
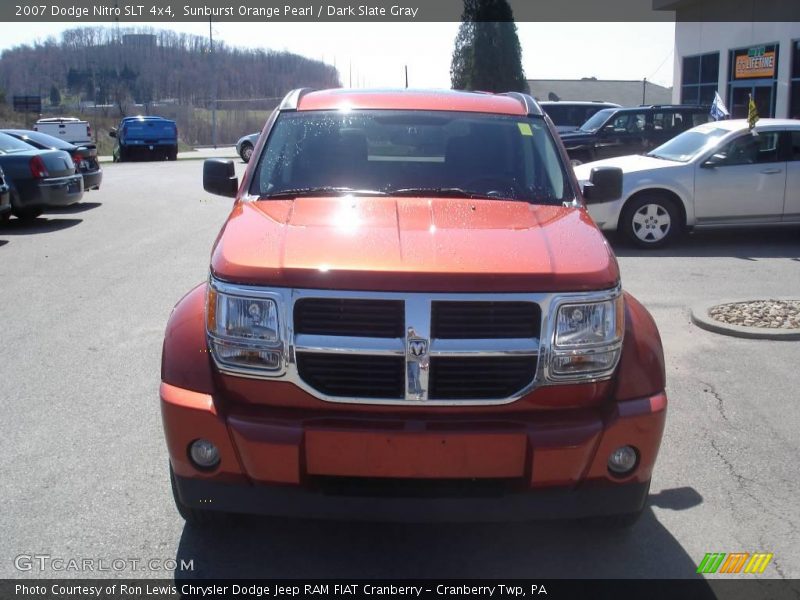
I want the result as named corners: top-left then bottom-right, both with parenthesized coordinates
top-left (528, 78), bottom-right (672, 106)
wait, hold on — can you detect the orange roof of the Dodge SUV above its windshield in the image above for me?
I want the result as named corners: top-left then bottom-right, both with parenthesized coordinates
top-left (297, 88), bottom-right (538, 115)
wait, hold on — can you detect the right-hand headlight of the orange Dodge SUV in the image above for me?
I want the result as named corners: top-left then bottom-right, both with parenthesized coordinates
top-left (549, 293), bottom-right (624, 380)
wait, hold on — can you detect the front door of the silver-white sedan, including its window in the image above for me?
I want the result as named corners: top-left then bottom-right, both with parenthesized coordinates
top-left (694, 131), bottom-right (787, 225)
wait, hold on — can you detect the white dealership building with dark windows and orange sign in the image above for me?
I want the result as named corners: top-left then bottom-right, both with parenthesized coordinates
top-left (664, 0), bottom-right (800, 119)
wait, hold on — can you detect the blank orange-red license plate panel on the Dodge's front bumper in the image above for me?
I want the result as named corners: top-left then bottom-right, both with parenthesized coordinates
top-left (305, 429), bottom-right (527, 479)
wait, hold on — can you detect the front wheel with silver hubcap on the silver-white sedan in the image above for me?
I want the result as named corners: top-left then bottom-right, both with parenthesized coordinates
top-left (620, 192), bottom-right (682, 248)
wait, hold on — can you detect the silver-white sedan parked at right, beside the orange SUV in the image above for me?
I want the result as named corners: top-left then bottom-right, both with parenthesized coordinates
top-left (575, 119), bottom-right (800, 248)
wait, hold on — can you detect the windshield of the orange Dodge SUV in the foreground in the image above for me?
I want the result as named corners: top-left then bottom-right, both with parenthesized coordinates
top-left (250, 110), bottom-right (574, 204)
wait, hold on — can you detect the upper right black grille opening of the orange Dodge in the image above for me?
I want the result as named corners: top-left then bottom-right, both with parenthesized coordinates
top-left (431, 301), bottom-right (542, 340)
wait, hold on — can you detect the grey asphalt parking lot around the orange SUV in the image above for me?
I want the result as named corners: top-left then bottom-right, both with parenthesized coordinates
top-left (0, 161), bottom-right (800, 579)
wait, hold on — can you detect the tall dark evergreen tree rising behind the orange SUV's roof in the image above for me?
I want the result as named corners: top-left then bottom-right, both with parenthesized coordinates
top-left (450, 0), bottom-right (528, 92)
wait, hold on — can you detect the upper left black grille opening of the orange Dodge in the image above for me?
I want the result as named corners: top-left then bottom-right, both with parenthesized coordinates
top-left (294, 298), bottom-right (405, 338)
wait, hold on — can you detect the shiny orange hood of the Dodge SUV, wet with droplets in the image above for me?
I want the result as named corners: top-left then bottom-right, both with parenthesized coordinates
top-left (211, 196), bottom-right (619, 292)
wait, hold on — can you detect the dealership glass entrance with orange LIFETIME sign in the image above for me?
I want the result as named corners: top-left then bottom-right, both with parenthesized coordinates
top-left (728, 44), bottom-right (779, 119)
